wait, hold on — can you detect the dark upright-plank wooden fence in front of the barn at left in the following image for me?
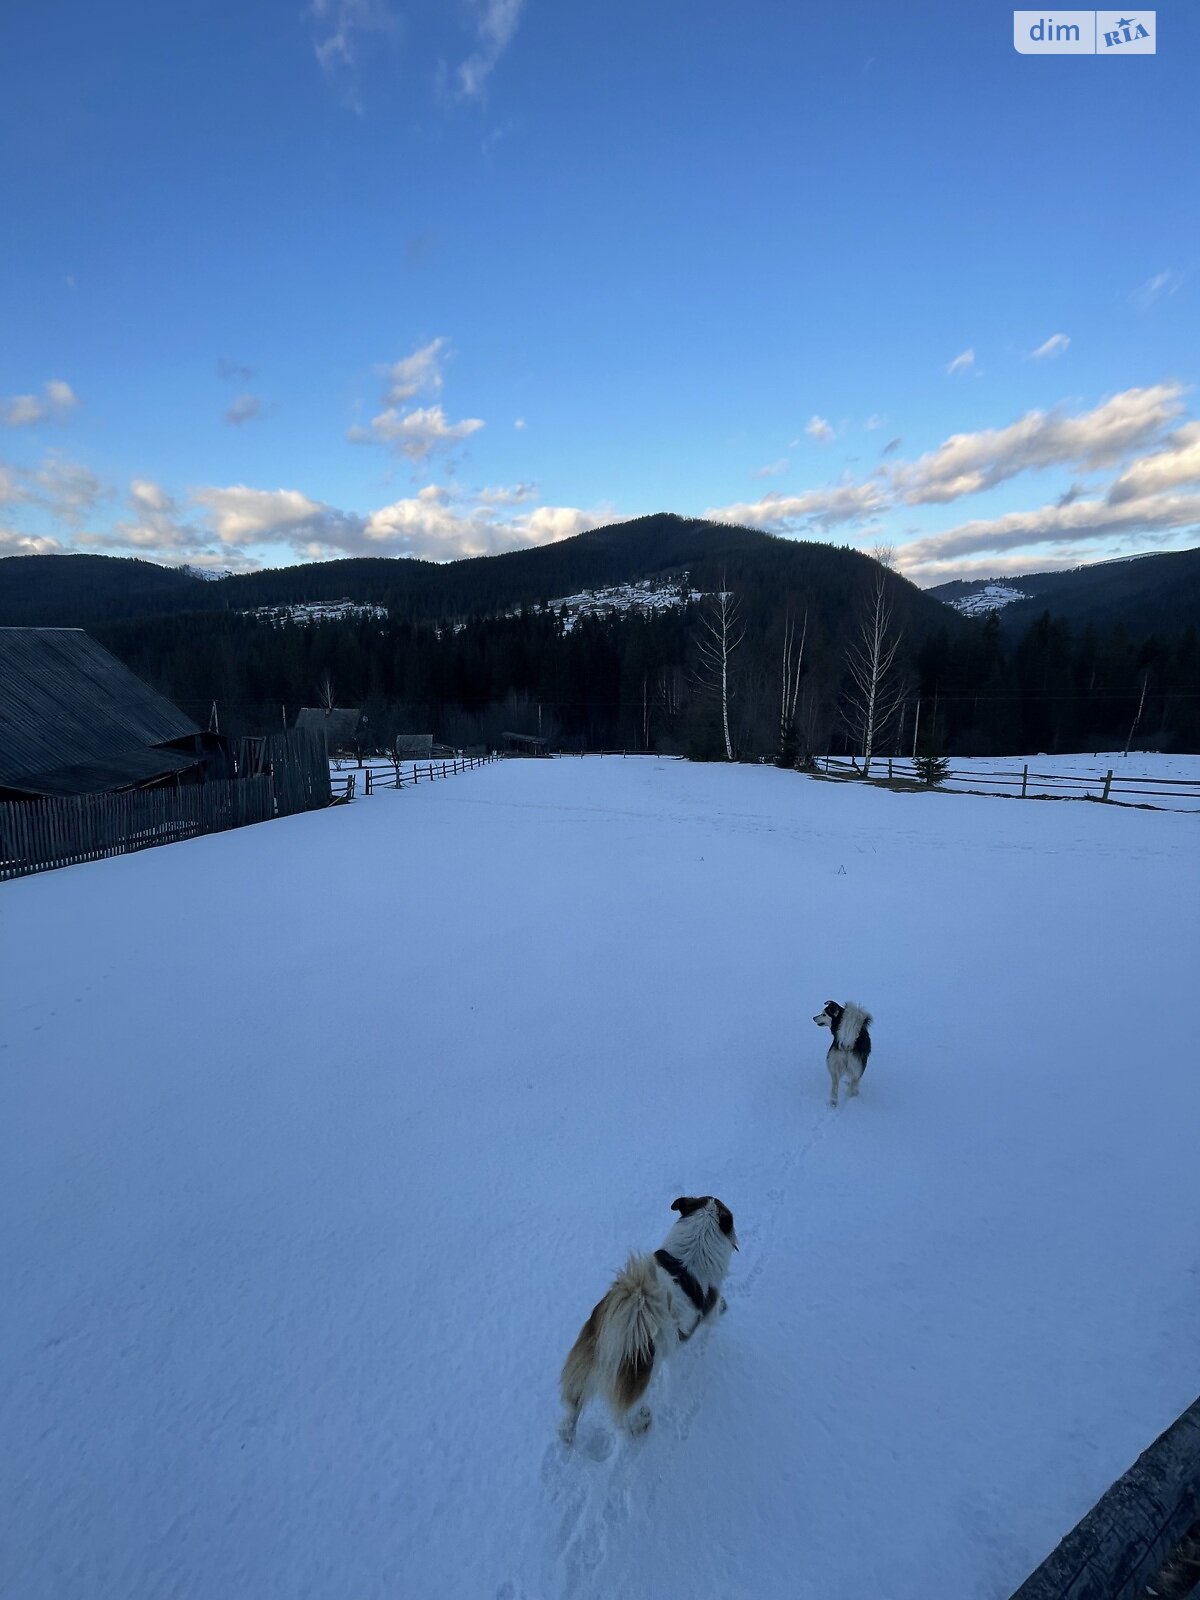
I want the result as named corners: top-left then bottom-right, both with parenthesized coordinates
top-left (0, 730), bottom-right (331, 880)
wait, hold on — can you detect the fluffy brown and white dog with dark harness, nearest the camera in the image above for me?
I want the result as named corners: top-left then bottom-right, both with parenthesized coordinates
top-left (558, 1195), bottom-right (738, 1445)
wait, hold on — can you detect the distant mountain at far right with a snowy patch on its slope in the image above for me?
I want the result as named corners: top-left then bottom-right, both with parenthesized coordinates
top-left (926, 549), bottom-right (1200, 637)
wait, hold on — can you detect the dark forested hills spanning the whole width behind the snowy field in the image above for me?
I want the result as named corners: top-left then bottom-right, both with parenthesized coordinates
top-left (0, 517), bottom-right (1200, 763)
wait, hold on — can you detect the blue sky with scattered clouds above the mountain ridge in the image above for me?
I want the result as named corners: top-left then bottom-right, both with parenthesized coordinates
top-left (0, 0), bottom-right (1200, 582)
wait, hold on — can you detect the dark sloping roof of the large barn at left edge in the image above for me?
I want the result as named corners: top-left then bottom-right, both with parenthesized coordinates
top-left (0, 627), bottom-right (200, 794)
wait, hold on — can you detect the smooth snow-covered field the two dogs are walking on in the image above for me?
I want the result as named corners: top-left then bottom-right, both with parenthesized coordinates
top-left (0, 760), bottom-right (1200, 1600)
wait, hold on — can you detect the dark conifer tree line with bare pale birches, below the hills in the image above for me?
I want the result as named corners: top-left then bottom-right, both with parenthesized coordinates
top-left (93, 552), bottom-right (1200, 765)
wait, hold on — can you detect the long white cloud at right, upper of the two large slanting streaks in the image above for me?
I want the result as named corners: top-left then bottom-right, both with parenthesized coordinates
top-left (893, 384), bottom-right (1182, 506)
